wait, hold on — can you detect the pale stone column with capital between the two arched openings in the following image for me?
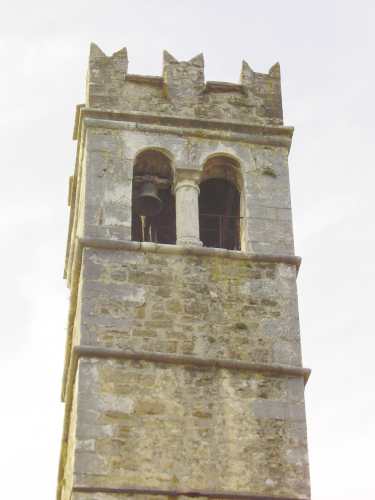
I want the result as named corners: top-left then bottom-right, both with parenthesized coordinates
top-left (175, 169), bottom-right (202, 246)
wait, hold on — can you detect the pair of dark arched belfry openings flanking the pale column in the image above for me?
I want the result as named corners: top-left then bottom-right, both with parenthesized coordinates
top-left (132, 150), bottom-right (241, 250)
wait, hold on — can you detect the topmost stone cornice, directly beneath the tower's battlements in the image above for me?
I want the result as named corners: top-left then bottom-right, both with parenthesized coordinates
top-left (73, 105), bottom-right (294, 146)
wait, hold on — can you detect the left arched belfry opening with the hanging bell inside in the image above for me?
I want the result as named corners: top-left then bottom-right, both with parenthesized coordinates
top-left (132, 150), bottom-right (176, 245)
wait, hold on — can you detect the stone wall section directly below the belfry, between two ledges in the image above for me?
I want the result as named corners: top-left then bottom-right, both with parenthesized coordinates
top-left (80, 249), bottom-right (301, 366)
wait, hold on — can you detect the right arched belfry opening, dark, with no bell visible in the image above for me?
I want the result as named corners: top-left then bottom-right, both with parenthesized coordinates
top-left (199, 157), bottom-right (241, 250)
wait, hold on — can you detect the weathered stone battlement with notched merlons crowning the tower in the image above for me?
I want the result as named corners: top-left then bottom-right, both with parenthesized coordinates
top-left (86, 43), bottom-right (283, 125)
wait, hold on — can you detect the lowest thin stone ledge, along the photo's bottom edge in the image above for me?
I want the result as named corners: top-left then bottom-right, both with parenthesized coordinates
top-left (73, 486), bottom-right (309, 500)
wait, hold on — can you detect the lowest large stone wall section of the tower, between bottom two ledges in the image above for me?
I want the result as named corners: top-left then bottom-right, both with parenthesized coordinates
top-left (75, 359), bottom-right (308, 500)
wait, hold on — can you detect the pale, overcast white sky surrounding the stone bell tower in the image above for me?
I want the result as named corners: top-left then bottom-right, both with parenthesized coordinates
top-left (0, 0), bottom-right (375, 500)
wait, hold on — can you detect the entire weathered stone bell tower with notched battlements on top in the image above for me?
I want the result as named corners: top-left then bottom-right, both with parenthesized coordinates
top-left (58, 45), bottom-right (310, 500)
